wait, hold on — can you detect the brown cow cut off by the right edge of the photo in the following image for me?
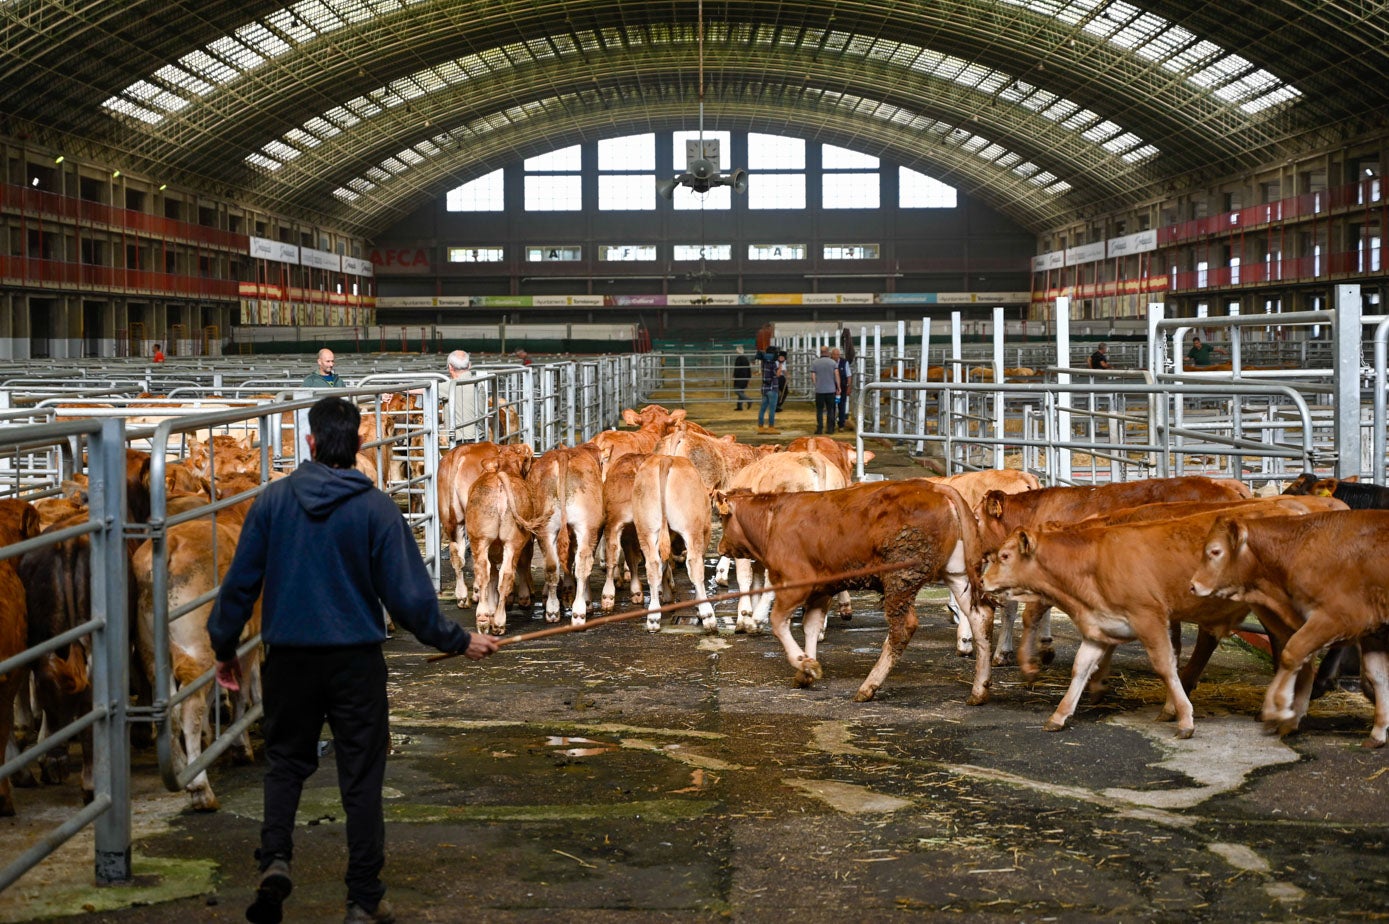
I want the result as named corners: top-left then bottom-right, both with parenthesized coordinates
top-left (1190, 510), bottom-right (1389, 748)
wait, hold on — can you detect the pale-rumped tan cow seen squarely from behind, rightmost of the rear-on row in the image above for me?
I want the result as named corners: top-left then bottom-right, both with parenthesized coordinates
top-left (632, 456), bottom-right (718, 632)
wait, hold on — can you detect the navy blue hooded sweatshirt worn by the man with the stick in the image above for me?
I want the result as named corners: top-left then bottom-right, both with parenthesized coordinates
top-left (207, 461), bottom-right (469, 661)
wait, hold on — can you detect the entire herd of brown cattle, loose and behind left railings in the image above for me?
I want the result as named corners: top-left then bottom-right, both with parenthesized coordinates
top-left (0, 404), bottom-right (1389, 816)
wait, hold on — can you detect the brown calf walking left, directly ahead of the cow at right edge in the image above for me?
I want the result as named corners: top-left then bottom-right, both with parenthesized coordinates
top-left (983, 503), bottom-right (1311, 738)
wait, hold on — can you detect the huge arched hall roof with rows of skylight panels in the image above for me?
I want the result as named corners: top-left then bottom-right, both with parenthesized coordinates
top-left (0, 0), bottom-right (1389, 235)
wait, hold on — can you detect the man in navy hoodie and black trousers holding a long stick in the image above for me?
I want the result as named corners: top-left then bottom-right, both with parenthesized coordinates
top-left (207, 397), bottom-right (497, 924)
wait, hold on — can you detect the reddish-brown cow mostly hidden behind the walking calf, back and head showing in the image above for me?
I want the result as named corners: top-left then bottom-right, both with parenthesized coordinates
top-left (976, 475), bottom-right (1240, 669)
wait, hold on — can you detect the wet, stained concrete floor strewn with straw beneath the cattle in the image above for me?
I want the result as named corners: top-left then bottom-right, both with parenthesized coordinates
top-left (0, 419), bottom-right (1389, 924)
